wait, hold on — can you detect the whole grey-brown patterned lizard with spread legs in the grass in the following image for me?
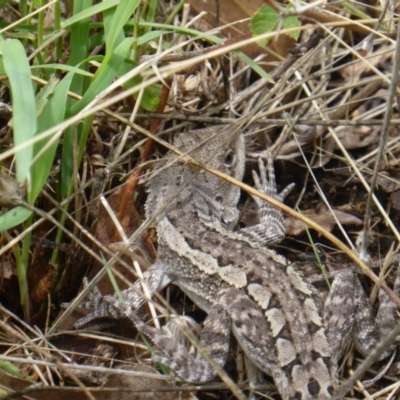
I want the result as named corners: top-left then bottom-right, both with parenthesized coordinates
top-left (70, 126), bottom-right (394, 400)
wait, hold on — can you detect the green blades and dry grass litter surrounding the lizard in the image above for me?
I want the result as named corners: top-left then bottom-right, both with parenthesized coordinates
top-left (0, 0), bottom-right (400, 399)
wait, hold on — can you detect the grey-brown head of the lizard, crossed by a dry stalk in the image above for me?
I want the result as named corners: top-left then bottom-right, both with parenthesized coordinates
top-left (146, 125), bottom-right (245, 224)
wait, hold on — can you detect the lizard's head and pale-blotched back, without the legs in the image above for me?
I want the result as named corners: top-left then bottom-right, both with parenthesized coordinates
top-left (146, 127), bottom-right (334, 400)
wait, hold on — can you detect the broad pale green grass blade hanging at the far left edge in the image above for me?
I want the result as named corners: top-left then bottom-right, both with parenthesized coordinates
top-left (0, 39), bottom-right (36, 182)
